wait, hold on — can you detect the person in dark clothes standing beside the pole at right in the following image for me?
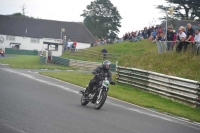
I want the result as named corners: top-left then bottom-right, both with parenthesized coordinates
top-left (166, 26), bottom-right (174, 51)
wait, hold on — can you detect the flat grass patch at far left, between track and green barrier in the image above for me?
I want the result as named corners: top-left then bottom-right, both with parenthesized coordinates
top-left (0, 55), bottom-right (72, 70)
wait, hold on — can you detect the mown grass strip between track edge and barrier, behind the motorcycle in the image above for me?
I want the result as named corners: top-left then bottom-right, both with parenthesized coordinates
top-left (42, 72), bottom-right (200, 122)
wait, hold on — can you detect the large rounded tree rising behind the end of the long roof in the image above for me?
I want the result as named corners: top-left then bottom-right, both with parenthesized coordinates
top-left (81, 0), bottom-right (122, 39)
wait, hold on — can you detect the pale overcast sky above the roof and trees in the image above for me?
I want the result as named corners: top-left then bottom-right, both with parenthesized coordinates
top-left (0, 0), bottom-right (166, 37)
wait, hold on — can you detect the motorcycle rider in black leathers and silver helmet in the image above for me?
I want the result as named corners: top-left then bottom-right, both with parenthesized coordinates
top-left (85, 60), bottom-right (115, 95)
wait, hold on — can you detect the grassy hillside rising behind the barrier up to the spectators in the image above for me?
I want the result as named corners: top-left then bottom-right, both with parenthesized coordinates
top-left (63, 40), bottom-right (200, 81)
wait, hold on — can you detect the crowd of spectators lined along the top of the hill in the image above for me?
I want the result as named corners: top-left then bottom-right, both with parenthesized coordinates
top-left (91, 23), bottom-right (200, 52)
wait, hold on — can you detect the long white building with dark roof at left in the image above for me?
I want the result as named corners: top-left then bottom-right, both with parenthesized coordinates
top-left (0, 15), bottom-right (95, 56)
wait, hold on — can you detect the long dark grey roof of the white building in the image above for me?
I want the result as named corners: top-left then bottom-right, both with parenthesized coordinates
top-left (0, 15), bottom-right (95, 43)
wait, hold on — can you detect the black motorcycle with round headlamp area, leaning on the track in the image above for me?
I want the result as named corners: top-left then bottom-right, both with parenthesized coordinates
top-left (79, 74), bottom-right (110, 110)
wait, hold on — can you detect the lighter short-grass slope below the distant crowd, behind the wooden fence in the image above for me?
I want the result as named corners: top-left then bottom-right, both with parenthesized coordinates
top-left (62, 40), bottom-right (155, 63)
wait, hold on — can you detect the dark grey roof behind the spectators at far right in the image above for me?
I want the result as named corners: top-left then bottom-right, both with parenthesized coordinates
top-left (161, 20), bottom-right (200, 30)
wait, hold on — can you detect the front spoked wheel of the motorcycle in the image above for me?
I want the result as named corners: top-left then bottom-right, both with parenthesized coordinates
top-left (94, 91), bottom-right (107, 110)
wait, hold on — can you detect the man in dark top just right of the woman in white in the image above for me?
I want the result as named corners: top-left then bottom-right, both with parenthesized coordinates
top-left (184, 23), bottom-right (195, 51)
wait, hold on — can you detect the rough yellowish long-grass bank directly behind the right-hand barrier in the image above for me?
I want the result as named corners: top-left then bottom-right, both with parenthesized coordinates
top-left (119, 52), bottom-right (200, 81)
